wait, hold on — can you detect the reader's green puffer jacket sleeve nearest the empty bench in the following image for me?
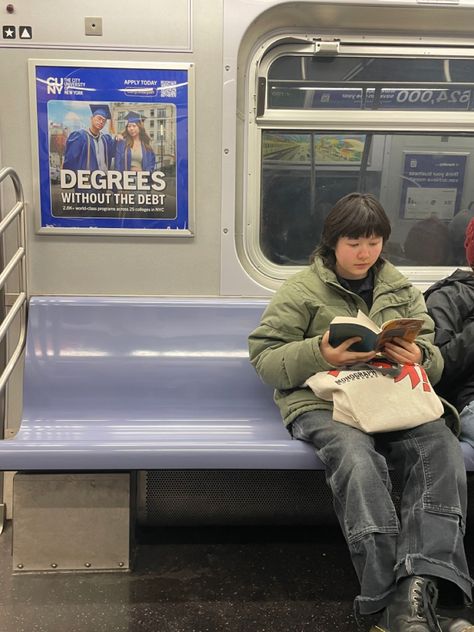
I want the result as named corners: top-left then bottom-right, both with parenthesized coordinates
top-left (249, 285), bottom-right (334, 390)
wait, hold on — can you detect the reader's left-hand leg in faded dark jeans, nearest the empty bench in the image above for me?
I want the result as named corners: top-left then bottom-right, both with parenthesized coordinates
top-left (291, 411), bottom-right (399, 614)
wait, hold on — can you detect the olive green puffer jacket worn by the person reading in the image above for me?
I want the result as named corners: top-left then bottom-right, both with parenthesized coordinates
top-left (249, 259), bottom-right (443, 425)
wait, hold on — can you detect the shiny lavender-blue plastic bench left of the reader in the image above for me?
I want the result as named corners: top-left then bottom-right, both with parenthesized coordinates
top-left (0, 297), bottom-right (323, 471)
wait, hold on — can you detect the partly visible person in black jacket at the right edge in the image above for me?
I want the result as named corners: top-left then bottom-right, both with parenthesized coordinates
top-left (425, 219), bottom-right (474, 447)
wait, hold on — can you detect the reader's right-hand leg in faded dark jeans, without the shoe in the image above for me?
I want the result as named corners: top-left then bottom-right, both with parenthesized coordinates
top-left (382, 420), bottom-right (472, 599)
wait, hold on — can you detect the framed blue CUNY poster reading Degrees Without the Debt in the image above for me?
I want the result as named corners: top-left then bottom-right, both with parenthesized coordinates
top-left (30, 60), bottom-right (193, 237)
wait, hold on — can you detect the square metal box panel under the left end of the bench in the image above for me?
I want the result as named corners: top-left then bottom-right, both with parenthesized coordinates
top-left (13, 473), bottom-right (130, 572)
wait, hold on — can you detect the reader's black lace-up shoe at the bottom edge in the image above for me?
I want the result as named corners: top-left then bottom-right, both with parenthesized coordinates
top-left (370, 575), bottom-right (442, 632)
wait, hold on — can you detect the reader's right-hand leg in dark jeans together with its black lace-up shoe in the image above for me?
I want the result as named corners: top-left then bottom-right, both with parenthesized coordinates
top-left (371, 420), bottom-right (474, 632)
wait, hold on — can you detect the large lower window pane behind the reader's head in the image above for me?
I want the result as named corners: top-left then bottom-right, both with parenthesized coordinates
top-left (260, 130), bottom-right (474, 266)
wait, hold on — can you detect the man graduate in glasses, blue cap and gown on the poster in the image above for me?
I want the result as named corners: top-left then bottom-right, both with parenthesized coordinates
top-left (63, 104), bottom-right (116, 172)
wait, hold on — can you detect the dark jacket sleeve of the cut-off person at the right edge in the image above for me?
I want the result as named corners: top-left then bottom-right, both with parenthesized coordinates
top-left (427, 288), bottom-right (474, 384)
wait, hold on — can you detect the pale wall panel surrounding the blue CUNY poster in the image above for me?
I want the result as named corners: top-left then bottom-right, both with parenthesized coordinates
top-left (0, 0), bottom-right (222, 295)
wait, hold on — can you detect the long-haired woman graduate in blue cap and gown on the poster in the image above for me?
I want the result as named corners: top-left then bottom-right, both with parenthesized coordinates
top-left (115, 112), bottom-right (156, 171)
